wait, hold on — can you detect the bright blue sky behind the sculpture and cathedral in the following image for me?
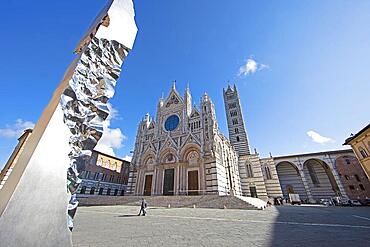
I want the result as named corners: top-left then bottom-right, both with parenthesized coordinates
top-left (0, 0), bottom-right (370, 167)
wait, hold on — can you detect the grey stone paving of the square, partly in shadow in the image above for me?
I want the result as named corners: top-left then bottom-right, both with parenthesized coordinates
top-left (73, 206), bottom-right (370, 247)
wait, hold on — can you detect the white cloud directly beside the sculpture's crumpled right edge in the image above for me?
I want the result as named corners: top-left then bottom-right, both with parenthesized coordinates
top-left (95, 104), bottom-right (127, 156)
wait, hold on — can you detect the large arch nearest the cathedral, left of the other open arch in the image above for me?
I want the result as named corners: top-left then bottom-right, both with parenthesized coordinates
top-left (276, 161), bottom-right (307, 200)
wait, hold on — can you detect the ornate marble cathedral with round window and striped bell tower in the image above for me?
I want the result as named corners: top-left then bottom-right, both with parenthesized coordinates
top-left (128, 83), bottom-right (282, 198)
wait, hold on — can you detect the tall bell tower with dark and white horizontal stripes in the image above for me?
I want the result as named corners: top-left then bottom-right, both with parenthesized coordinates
top-left (223, 84), bottom-right (251, 156)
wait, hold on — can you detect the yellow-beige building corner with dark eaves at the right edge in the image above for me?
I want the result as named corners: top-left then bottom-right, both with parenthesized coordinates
top-left (343, 124), bottom-right (370, 179)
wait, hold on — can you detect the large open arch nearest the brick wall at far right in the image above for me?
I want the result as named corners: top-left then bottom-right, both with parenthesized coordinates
top-left (303, 159), bottom-right (340, 200)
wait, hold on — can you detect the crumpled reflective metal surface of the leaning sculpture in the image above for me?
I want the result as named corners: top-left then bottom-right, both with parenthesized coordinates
top-left (60, 37), bottom-right (129, 230)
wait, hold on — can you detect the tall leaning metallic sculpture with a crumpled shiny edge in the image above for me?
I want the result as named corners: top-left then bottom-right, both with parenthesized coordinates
top-left (0, 0), bottom-right (137, 246)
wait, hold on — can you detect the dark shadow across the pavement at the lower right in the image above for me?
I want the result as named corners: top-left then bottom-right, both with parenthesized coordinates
top-left (269, 206), bottom-right (370, 247)
